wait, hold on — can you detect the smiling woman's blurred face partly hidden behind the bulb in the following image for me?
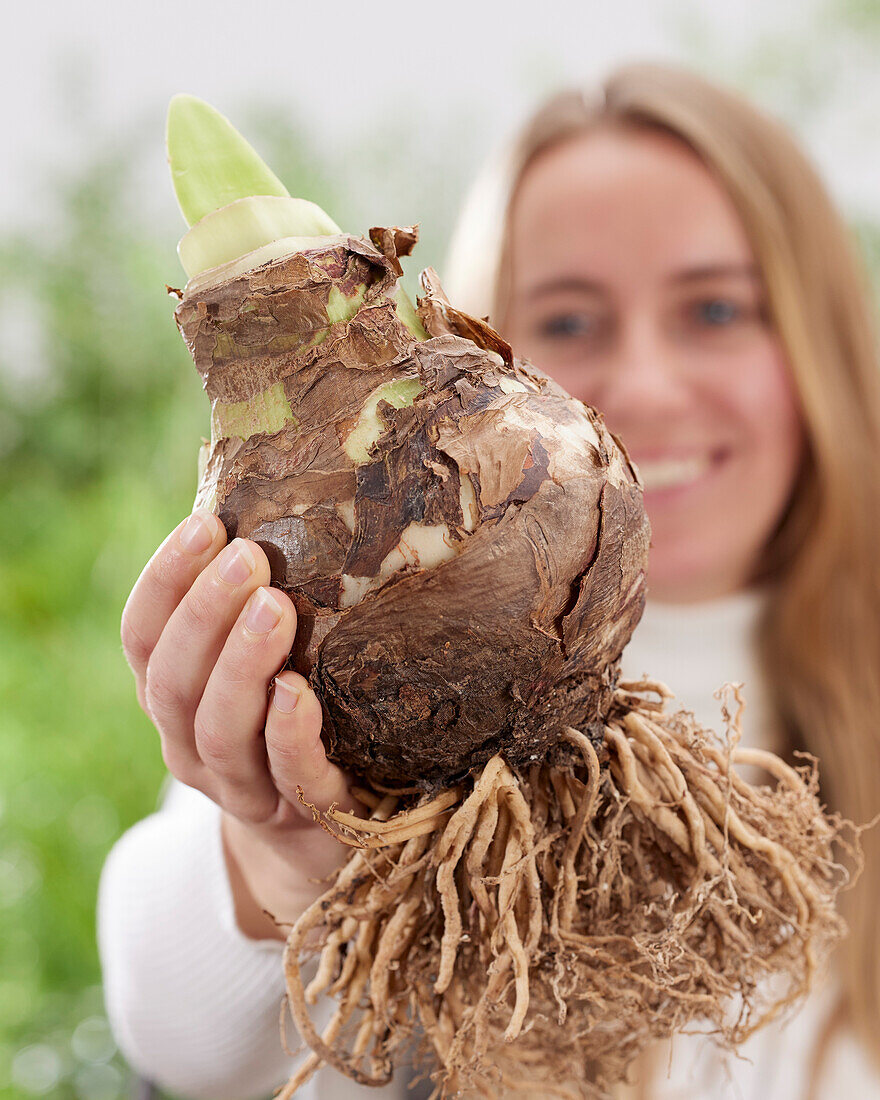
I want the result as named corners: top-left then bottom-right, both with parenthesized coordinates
top-left (501, 128), bottom-right (804, 602)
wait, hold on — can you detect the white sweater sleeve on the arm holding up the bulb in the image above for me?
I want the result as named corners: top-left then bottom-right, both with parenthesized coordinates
top-left (98, 782), bottom-right (318, 1100)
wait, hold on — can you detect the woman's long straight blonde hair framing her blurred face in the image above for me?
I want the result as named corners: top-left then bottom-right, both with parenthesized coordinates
top-left (446, 65), bottom-right (880, 1065)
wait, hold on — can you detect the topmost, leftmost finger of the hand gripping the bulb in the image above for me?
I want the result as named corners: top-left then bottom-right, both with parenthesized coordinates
top-left (121, 508), bottom-right (227, 706)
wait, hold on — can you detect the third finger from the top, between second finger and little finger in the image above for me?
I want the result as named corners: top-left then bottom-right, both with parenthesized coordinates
top-left (194, 587), bottom-right (296, 823)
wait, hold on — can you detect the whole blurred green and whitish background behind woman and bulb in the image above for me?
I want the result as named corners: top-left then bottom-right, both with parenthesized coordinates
top-left (0, 0), bottom-right (880, 1100)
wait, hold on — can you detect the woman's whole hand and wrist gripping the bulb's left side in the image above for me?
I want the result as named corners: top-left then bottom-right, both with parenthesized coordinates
top-left (122, 509), bottom-right (353, 938)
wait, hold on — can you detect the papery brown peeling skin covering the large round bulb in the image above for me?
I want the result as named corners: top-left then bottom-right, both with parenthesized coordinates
top-left (175, 230), bottom-right (649, 789)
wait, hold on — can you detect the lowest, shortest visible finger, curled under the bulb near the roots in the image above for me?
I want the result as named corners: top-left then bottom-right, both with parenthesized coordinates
top-left (266, 672), bottom-right (351, 820)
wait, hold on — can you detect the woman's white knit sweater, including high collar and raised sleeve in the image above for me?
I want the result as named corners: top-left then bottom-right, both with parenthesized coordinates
top-left (98, 593), bottom-right (880, 1100)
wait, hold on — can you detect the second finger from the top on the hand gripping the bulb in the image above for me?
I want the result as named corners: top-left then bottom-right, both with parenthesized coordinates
top-left (145, 539), bottom-right (270, 785)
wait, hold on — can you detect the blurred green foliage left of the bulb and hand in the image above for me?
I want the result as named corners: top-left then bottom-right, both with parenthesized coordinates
top-left (0, 111), bottom-right (347, 1100)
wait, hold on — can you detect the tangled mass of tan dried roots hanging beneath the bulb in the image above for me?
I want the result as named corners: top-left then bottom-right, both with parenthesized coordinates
top-left (279, 682), bottom-right (846, 1100)
